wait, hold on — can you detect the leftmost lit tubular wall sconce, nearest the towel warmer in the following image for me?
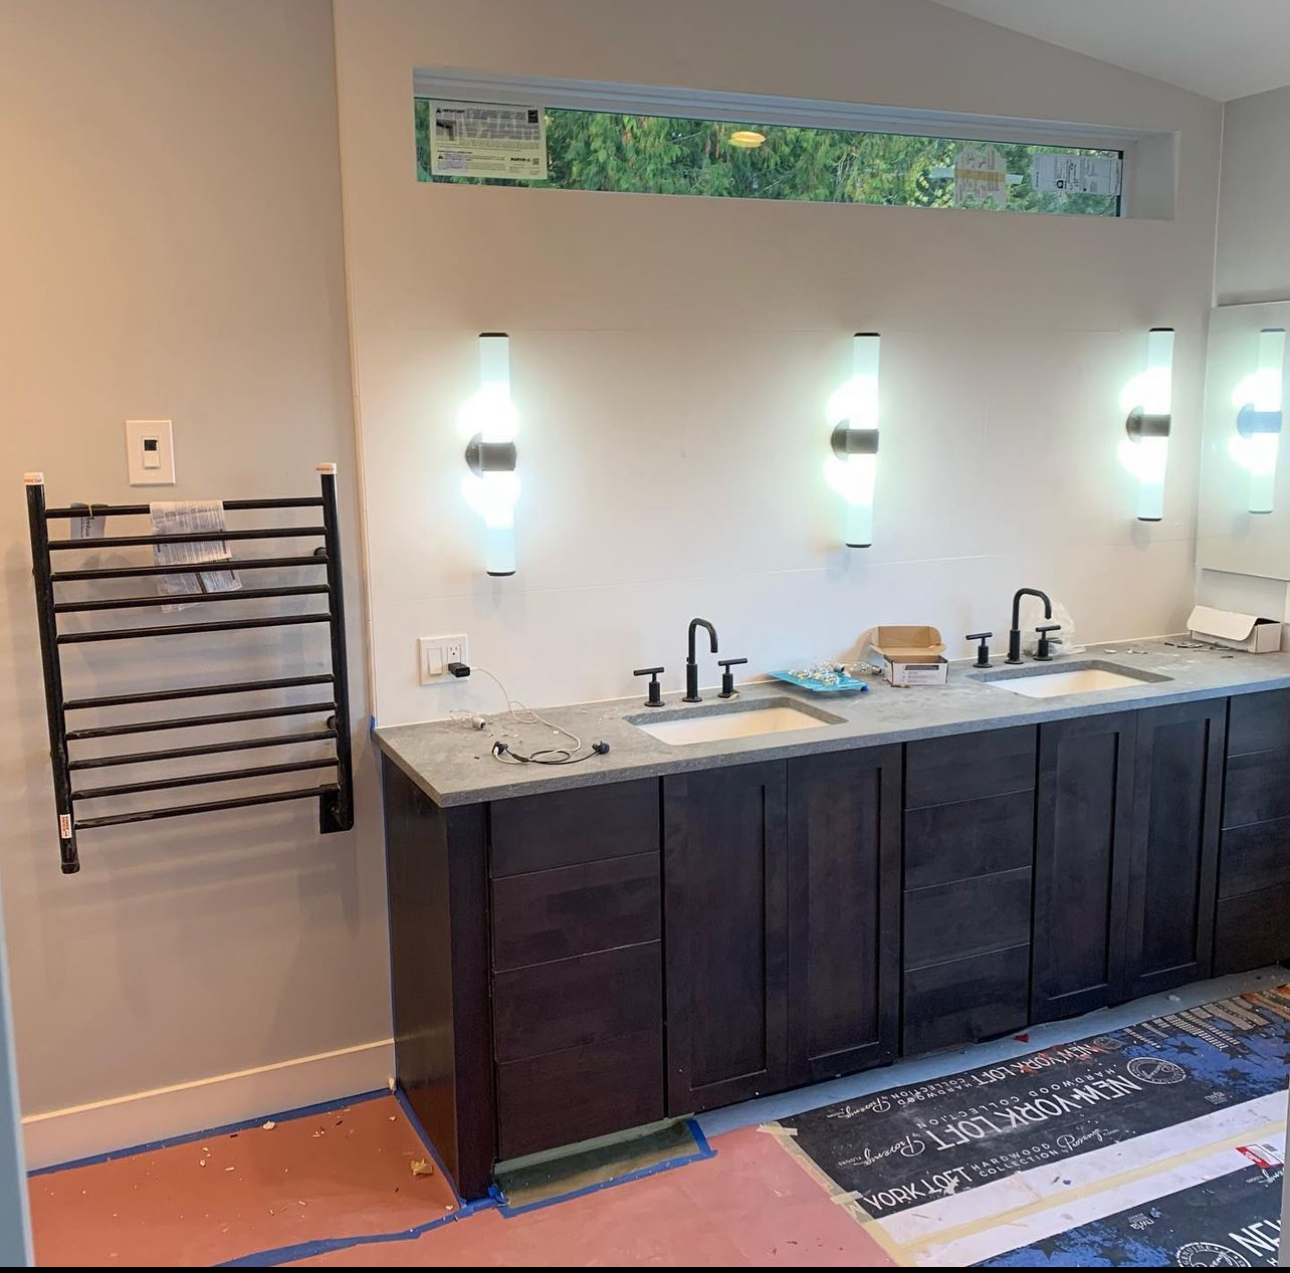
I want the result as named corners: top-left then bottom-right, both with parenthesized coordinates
top-left (457, 331), bottom-right (520, 575)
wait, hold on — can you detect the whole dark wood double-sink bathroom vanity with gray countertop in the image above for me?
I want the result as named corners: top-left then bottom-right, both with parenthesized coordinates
top-left (377, 642), bottom-right (1290, 1198)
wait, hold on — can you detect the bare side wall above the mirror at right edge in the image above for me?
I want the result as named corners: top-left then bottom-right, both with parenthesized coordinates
top-left (1214, 88), bottom-right (1290, 304)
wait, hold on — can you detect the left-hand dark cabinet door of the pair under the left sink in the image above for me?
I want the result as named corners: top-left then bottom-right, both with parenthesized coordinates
top-left (663, 762), bottom-right (788, 1114)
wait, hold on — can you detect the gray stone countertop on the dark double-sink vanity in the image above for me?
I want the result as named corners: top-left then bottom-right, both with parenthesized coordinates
top-left (375, 637), bottom-right (1290, 807)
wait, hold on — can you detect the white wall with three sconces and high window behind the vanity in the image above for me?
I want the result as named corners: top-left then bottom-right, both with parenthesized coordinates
top-left (335, 0), bottom-right (1220, 724)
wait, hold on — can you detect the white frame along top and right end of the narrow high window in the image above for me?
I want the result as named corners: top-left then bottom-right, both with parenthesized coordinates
top-left (413, 67), bottom-right (1174, 219)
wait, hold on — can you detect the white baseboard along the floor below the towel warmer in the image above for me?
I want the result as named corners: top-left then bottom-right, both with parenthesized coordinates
top-left (22, 1038), bottom-right (395, 1171)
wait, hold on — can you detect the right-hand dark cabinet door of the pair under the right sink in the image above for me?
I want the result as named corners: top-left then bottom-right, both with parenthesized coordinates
top-left (1125, 699), bottom-right (1227, 998)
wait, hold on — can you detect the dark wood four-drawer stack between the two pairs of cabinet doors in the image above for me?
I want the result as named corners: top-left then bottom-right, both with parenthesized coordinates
top-left (902, 726), bottom-right (1037, 1055)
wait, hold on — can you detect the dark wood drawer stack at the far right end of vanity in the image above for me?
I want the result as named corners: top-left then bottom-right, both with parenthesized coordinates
top-left (1214, 690), bottom-right (1290, 974)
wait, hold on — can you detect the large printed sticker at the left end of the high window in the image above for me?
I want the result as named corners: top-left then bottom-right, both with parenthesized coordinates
top-left (430, 102), bottom-right (547, 181)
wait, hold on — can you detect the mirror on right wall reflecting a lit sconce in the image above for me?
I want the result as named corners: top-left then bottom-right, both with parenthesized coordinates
top-left (1196, 301), bottom-right (1290, 579)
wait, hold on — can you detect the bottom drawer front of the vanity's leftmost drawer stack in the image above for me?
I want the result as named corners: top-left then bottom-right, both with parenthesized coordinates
top-left (497, 1027), bottom-right (664, 1160)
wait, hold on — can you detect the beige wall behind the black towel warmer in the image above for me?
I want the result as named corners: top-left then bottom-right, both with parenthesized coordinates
top-left (0, 0), bottom-right (390, 1152)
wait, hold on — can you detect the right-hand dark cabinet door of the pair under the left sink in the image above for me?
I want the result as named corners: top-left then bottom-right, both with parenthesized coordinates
top-left (788, 747), bottom-right (900, 1085)
